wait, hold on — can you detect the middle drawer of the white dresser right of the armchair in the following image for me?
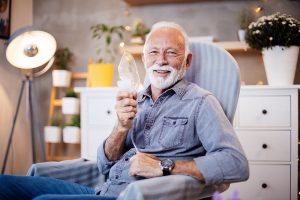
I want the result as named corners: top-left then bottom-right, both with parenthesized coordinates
top-left (236, 130), bottom-right (291, 162)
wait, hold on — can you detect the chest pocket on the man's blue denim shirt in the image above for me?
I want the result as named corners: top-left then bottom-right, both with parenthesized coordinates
top-left (158, 117), bottom-right (188, 148)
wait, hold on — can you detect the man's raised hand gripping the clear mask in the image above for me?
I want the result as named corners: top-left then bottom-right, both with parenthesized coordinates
top-left (115, 91), bottom-right (137, 131)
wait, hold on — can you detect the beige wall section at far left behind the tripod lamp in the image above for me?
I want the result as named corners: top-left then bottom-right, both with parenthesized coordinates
top-left (0, 0), bottom-right (33, 174)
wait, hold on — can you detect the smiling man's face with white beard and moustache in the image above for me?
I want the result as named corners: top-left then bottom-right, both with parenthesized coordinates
top-left (144, 28), bottom-right (186, 89)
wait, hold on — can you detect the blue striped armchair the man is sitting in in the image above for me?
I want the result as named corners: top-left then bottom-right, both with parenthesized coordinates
top-left (27, 42), bottom-right (240, 200)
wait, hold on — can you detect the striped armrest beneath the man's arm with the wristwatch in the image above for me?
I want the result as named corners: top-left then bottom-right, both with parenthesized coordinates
top-left (118, 175), bottom-right (229, 200)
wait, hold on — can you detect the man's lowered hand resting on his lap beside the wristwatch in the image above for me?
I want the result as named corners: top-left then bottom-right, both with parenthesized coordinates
top-left (129, 153), bottom-right (163, 178)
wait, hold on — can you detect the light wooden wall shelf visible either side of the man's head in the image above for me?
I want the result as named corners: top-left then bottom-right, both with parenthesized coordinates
top-left (122, 41), bottom-right (255, 55)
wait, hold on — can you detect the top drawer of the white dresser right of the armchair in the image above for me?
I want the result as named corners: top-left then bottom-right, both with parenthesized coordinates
top-left (235, 95), bottom-right (291, 128)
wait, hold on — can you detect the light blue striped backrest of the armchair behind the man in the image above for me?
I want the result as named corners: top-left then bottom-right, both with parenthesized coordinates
top-left (186, 41), bottom-right (240, 123)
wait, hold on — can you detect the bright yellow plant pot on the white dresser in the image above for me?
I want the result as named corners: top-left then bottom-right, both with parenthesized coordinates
top-left (87, 63), bottom-right (114, 87)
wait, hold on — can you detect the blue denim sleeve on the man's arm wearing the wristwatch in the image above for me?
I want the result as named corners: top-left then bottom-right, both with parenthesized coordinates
top-left (194, 95), bottom-right (249, 185)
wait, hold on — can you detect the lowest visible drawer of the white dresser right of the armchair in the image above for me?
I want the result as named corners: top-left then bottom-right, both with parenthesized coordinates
top-left (222, 165), bottom-right (291, 200)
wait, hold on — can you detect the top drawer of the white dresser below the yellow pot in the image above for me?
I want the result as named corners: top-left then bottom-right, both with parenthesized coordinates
top-left (86, 96), bottom-right (117, 126)
